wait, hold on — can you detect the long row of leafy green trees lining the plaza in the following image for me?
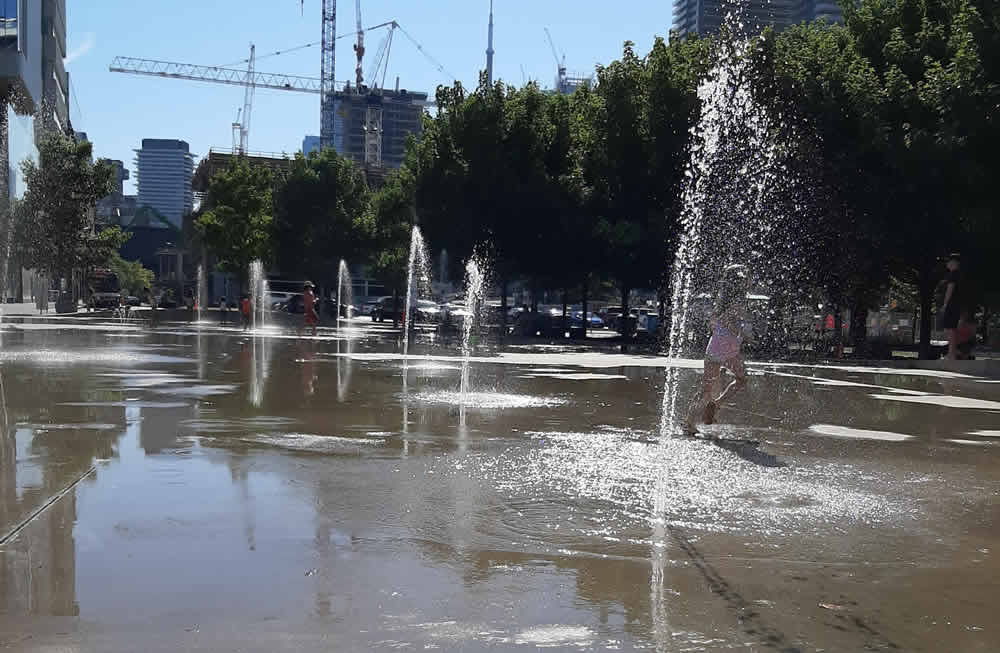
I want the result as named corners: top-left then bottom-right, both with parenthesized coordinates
top-left (191, 0), bottom-right (1000, 356)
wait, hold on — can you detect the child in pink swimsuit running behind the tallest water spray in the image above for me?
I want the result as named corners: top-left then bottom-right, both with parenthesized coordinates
top-left (684, 265), bottom-right (749, 435)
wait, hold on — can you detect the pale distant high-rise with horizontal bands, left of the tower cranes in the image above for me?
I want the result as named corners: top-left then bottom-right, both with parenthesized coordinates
top-left (135, 138), bottom-right (194, 227)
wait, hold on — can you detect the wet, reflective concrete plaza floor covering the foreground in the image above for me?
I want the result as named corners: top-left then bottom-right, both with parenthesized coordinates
top-left (0, 320), bottom-right (1000, 651)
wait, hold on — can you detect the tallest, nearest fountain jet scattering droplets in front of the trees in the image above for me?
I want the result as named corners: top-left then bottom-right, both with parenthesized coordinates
top-left (660, 14), bottom-right (798, 437)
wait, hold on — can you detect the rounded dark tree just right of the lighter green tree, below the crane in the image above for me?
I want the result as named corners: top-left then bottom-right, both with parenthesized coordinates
top-left (271, 148), bottom-right (369, 284)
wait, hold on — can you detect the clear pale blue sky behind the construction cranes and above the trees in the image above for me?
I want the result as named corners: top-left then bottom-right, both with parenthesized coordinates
top-left (66, 0), bottom-right (672, 192)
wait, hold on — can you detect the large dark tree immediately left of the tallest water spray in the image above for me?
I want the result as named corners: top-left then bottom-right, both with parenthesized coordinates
top-left (573, 40), bottom-right (708, 346)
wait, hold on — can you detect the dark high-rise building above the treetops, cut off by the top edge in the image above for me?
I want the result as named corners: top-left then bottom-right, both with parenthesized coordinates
top-left (673, 0), bottom-right (843, 36)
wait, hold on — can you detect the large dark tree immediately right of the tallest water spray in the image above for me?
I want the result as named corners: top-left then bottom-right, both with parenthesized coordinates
top-left (752, 23), bottom-right (891, 347)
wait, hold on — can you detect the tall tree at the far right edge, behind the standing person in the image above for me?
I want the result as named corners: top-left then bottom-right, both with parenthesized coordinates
top-left (844, 0), bottom-right (997, 356)
